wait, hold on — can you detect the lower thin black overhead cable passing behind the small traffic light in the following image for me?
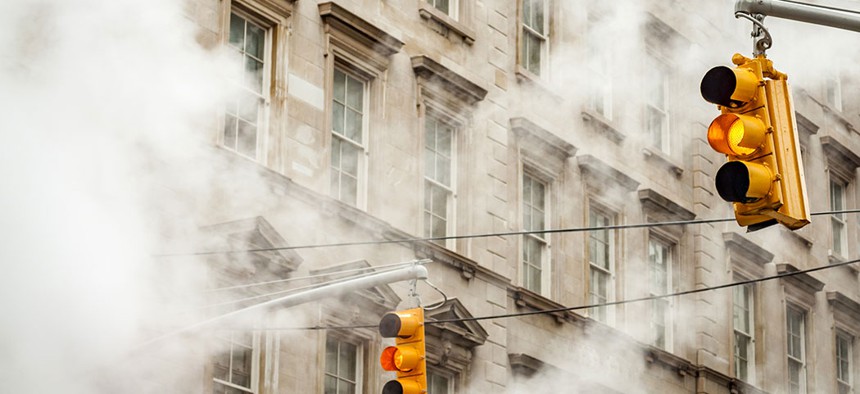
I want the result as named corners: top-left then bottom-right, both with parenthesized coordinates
top-left (253, 259), bottom-right (860, 331)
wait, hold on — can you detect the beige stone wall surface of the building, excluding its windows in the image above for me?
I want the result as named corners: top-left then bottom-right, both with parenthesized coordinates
top-left (175, 0), bottom-right (860, 393)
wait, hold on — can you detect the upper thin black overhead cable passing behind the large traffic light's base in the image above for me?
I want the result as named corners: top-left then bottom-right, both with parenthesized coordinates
top-left (153, 209), bottom-right (860, 257)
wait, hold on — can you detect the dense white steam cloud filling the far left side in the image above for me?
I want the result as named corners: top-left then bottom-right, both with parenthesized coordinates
top-left (0, 0), bottom-right (232, 393)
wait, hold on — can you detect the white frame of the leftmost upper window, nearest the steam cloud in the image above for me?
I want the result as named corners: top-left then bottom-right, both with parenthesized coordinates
top-left (222, 4), bottom-right (279, 163)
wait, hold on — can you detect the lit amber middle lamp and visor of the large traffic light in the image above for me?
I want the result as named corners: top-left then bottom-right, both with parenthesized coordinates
top-left (708, 114), bottom-right (765, 156)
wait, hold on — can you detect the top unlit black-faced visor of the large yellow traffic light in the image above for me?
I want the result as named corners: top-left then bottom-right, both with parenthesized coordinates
top-left (700, 66), bottom-right (758, 108)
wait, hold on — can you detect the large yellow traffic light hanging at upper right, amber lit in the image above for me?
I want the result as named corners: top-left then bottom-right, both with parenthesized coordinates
top-left (701, 54), bottom-right (809, 231)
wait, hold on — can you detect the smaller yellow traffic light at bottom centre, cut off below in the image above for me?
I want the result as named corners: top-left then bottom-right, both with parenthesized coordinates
top-left (379, 308), bottom-right (427, 394)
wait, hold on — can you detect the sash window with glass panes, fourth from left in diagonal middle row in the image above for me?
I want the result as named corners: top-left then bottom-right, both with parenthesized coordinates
top-left (522, 174), bottom-right (549, 294)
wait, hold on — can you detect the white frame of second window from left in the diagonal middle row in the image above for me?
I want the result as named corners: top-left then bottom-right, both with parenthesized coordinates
top-left (327, 63), bottom-right (373, 209)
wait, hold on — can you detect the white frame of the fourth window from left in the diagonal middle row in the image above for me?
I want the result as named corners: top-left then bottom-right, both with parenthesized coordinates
top-left (519, 169), bottom-right (552, 297)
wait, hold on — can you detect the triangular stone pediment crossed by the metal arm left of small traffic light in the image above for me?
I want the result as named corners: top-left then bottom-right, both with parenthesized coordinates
top-left (309, 260), bottom-right (401, 319)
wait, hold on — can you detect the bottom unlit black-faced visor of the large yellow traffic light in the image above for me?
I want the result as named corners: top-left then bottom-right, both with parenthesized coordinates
top-left (716, 161), bottom-right (773, 203)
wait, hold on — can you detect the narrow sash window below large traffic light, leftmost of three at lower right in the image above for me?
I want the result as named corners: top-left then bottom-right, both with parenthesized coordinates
top-left (732, 285), bottom-right (755, 382)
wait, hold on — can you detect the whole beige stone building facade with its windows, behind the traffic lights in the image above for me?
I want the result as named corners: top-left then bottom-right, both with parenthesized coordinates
top-left (163, 0), bottom-right (860, 394)
